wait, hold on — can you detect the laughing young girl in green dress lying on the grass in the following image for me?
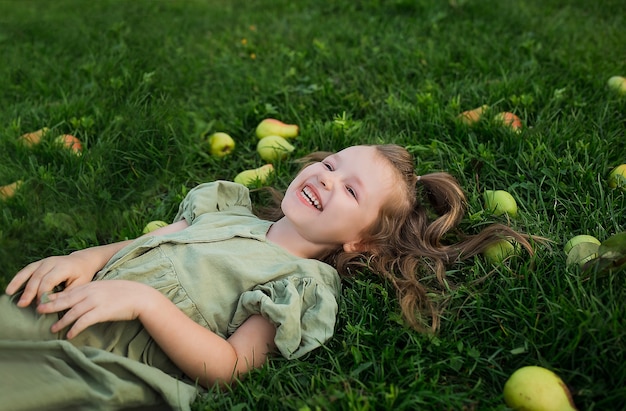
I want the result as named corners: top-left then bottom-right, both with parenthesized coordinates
top-left (0, 145), bottom-right (532, 410)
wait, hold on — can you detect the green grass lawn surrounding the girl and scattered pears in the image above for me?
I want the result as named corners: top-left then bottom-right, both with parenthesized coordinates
top-left (0, 0), bottom-right (626, 410)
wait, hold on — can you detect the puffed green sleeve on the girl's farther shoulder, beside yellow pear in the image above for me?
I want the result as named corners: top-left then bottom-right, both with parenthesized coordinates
top-left (174, 181), bottom-right (252, 225)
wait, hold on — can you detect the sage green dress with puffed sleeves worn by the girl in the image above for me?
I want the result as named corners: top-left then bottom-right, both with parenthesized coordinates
top-left (0, 181), bottom-right (341, 411)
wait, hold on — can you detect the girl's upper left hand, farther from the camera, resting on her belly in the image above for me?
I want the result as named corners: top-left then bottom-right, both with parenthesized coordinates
top-left (6, 253), bottom-right (98, 307)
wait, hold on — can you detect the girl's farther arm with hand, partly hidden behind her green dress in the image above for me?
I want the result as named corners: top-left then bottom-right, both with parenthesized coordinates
top-left (6, 220), bottom-right (188, 307)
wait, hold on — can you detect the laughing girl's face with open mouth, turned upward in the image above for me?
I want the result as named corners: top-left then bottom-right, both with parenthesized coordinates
top-left (281, 146), bottom-right (398, 251)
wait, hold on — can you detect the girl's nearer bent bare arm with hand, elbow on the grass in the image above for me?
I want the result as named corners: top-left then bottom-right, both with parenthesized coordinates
top-left (38, 280), bottom-right (276, 387)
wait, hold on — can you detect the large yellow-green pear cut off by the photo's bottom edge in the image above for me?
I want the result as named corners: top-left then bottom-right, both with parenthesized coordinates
top-left (504, 365), bottom-right (576, 411)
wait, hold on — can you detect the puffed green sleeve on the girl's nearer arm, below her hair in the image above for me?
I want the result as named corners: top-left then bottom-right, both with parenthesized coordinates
top-left (229, 276), bottom-right (338, 359)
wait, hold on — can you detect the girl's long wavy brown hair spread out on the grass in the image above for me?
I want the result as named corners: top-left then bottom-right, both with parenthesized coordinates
top-left (251, 144), bottom-right (533, 332)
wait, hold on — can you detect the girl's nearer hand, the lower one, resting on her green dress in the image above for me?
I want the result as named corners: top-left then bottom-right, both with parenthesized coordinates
top-left (37, 280), bottom-right (156, 339)
